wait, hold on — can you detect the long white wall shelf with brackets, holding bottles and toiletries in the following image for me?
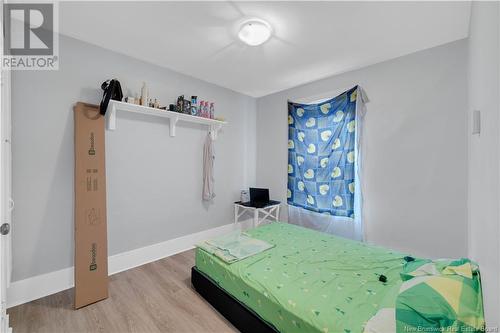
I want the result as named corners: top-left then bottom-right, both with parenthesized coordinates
top-left (106, 100), bottom-right (227, 140)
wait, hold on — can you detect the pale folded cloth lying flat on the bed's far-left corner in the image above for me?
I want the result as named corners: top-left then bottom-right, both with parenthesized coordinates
top-left (196, 231), bottom-right (274, 264)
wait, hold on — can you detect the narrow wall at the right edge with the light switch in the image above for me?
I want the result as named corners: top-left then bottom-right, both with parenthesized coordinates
top-left (467, 2), bottom-right (500, 328)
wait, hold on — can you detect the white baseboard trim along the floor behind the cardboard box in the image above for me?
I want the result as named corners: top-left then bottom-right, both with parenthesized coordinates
top-left (7, 220), bottom-right (252, 308)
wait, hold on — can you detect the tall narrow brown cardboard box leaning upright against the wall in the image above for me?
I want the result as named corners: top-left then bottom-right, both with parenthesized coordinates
top-left (74, 102), bottom-right (108, 309)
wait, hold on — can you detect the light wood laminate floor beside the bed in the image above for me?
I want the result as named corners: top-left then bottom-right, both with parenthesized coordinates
top-left (8, 250), bottom-right (237, 333)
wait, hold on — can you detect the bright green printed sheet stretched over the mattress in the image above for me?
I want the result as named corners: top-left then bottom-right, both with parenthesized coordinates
top-left (196, 223), bottom-right (406, 333)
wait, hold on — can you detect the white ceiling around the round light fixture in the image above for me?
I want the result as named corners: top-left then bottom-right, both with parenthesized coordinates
top-left (59, 1), bottom-right (470, 97)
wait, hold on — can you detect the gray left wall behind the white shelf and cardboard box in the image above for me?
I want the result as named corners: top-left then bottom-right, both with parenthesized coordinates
top-left (12, 36), bottom-right (256, 281)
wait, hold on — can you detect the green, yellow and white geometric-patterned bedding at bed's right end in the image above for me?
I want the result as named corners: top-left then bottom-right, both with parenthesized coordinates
top-left (396, 259), bottom-right (485, 332)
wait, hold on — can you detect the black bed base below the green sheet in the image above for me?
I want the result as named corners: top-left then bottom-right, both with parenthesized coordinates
top-left (191, 266), bottom-right (278, 333)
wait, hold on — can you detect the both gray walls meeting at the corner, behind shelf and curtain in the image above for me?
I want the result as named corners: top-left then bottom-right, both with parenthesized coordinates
top-left (12, 33), bottom-right (467, 281)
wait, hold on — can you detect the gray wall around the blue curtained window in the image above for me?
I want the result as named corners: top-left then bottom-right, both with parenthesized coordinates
top-left (257, 40), bottom-right (467, 257)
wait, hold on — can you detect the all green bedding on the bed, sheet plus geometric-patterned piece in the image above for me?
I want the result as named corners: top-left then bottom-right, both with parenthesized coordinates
top-left (196, 223), bottom-right (484, 333)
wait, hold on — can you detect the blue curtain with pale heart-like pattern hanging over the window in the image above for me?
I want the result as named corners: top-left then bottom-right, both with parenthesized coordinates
top-left (287, 87), bottom-right (359, 218)
